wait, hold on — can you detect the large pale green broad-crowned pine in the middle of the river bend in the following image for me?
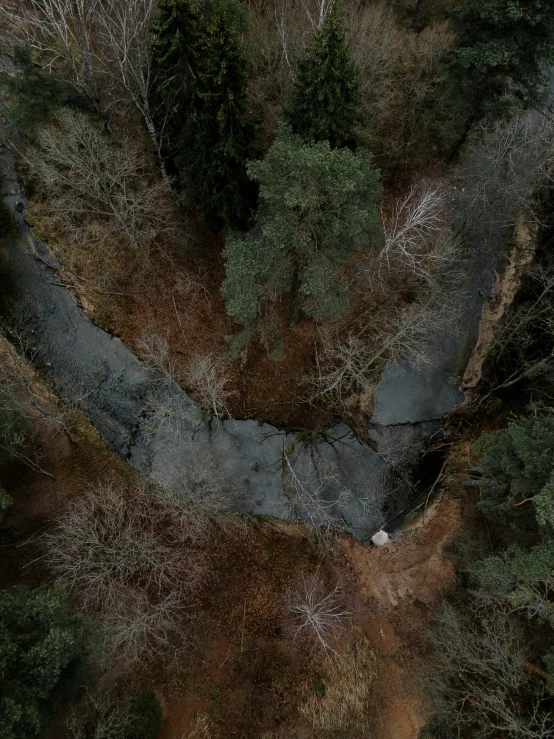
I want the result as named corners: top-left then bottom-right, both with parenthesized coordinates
top-left (222, 125), bottom-right (382, 346)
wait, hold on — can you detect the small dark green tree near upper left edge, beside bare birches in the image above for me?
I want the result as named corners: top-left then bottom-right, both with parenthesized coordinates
top-left (3, 46), bottom-right (88, 135)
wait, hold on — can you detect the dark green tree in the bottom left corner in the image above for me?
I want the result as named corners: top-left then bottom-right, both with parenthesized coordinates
top-left (0, 586), bottom-right (98, 739)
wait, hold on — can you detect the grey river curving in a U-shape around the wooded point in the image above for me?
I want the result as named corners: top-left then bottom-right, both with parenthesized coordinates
top-left (0, 72), bottom-right (548, 539)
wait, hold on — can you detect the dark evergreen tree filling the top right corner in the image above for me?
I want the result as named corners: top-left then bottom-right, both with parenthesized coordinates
top-left (438, 0), bottom-right (554, 158)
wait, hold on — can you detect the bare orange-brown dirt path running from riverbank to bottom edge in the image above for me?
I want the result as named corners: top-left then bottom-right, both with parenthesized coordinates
top-left (344, 496), bottom-right (466, 739)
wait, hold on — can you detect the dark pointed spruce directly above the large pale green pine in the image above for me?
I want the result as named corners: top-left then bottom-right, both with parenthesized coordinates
top-left (287, 0), bottom-right (363, 149)
